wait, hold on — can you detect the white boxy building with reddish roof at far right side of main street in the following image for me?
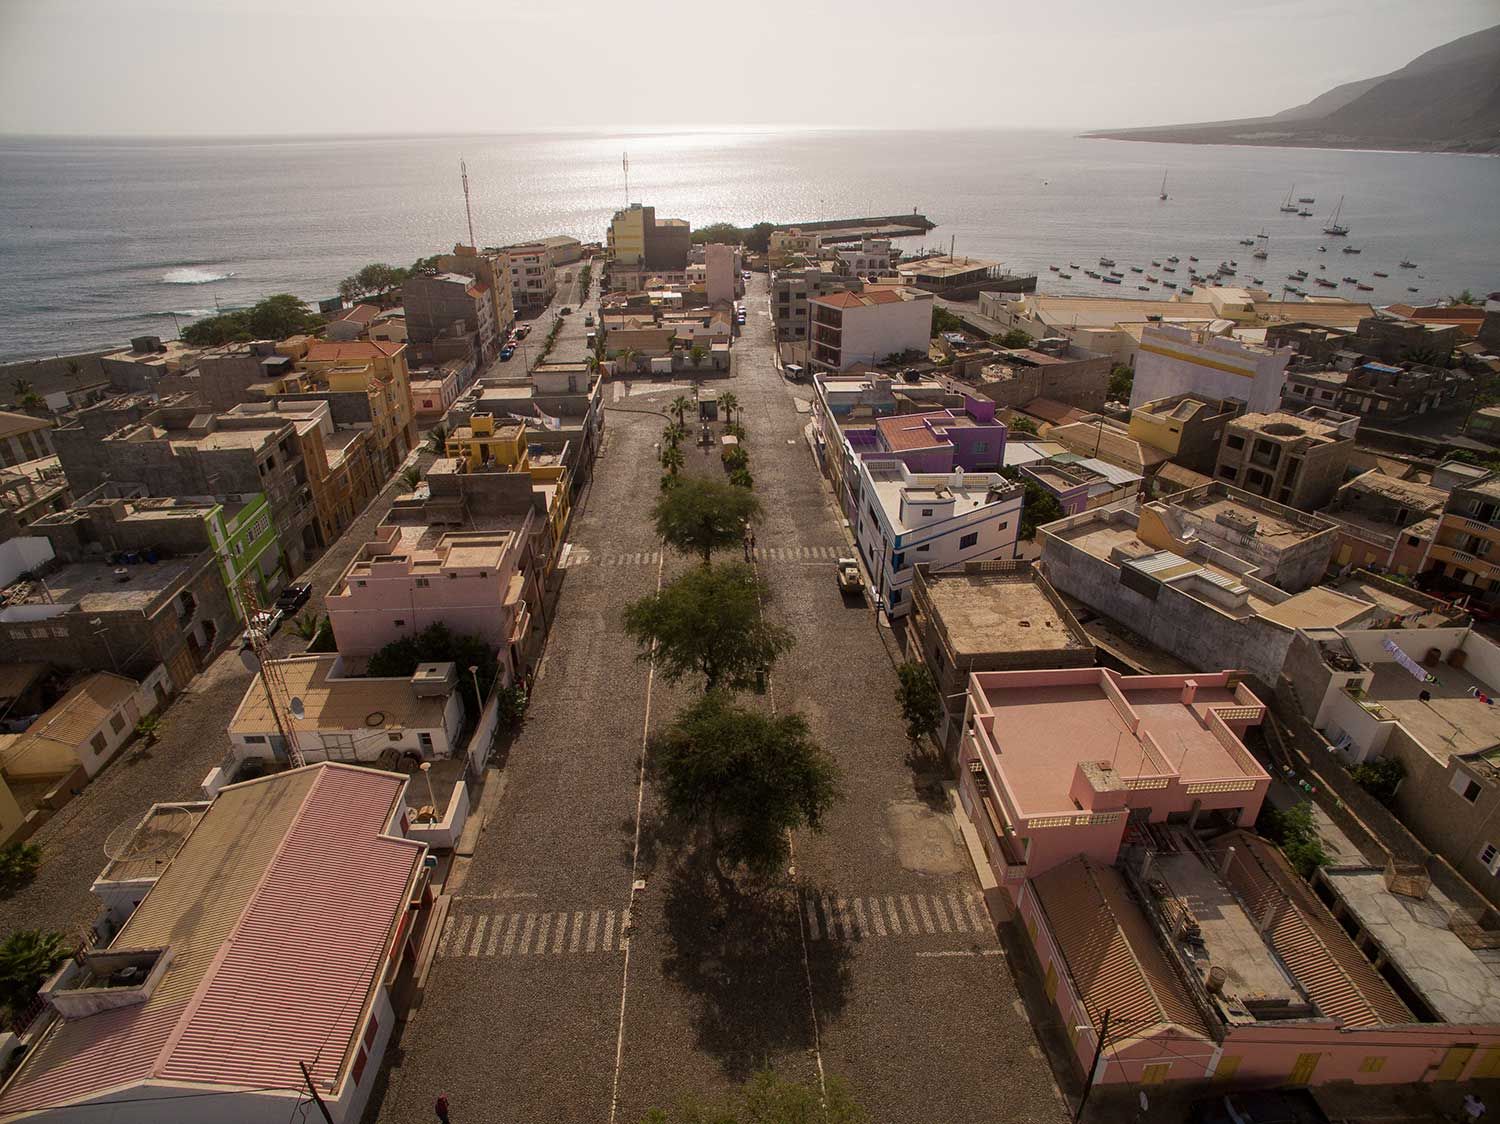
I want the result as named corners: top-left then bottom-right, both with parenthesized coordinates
top-left (807, 288), bottom-right (933, 371)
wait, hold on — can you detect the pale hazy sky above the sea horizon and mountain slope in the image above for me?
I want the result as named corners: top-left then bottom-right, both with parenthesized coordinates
top-left (0, 0), bottom-right (1500, 137)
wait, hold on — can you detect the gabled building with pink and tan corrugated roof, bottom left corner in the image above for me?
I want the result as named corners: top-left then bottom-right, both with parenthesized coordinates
top-left (0, 765), bottom-right (432, 1124)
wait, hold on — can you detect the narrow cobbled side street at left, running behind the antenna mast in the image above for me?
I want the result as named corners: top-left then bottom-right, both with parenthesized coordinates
top-left (0, 458), bottom-right (431, 935)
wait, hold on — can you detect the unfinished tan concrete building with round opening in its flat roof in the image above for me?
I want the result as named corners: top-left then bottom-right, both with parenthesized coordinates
top-left (1214, 411), bottom-right (1359, 512)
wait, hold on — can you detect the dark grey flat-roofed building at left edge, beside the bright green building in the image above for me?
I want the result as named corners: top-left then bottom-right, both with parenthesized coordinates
top-left (0, 539), bottom-right (239, 690)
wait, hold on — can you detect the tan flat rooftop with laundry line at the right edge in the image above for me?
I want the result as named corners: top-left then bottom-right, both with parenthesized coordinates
top-left (1365, 657), bottom-right (1500, 762)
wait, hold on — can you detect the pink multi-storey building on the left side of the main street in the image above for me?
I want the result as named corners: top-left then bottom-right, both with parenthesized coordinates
top-left (324, 510), bottom-right (539, 683)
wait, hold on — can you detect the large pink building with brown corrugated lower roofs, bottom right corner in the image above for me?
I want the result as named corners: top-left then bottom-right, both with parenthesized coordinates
top-left (960, 668), bottom-right (1500, 1086)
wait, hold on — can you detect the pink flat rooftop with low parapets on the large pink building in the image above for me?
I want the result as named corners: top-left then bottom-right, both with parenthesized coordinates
top-left (981, 672), bottom-right (1245, 815)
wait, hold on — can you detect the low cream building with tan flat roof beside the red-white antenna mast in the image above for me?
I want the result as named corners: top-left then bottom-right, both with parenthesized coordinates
top-left (224, 653), bottom-right (467, 776)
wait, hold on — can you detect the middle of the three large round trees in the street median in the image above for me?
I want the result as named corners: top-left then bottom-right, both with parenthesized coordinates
top-left (624, 561), bottom-right (795, 690)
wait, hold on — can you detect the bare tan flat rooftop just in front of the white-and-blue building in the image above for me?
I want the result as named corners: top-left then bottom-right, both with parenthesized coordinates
top-left (926, 573), bottom-right (1094, 656)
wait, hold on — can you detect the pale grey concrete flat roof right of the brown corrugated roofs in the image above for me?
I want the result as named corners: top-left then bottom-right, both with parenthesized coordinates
top-left (1322, 867), bottom-right (1500, 1023)
